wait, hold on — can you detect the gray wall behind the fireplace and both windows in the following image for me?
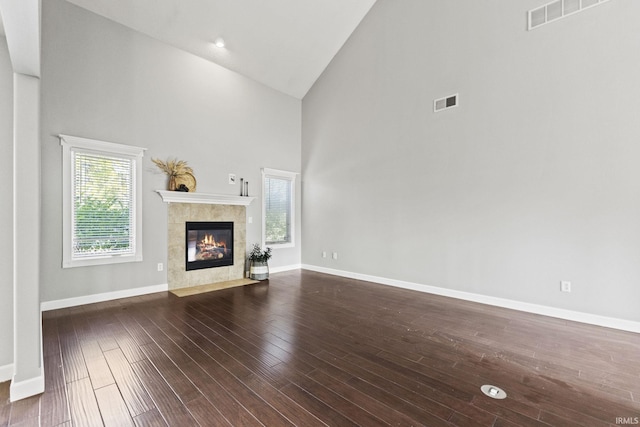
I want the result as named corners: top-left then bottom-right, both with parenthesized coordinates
top-left (41, 0), bottom-right (301, 301)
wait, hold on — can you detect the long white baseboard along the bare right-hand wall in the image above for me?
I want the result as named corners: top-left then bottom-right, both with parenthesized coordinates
top-left (302, 264), bottom-right (640, 333)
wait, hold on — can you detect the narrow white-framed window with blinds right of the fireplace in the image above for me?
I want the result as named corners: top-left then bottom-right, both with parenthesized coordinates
top-left (262, 169), bottom-right (296, 247)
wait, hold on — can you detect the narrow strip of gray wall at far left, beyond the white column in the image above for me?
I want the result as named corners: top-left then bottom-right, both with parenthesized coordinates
top-left (0, 36), bottom-right (13, 367)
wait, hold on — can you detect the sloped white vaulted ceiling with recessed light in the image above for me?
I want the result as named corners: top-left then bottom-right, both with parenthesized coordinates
top-left (67, 0), bottom-right (376, 99)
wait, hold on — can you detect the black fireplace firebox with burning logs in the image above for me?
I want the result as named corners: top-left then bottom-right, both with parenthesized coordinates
top-left (185, 221), bottom-right (233, 271)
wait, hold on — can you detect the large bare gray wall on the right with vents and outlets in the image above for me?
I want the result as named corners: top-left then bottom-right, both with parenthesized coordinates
top-left (302, 0), bottom-right (640, 321)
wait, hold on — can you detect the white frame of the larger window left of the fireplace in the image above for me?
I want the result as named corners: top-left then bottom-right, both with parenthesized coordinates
top-left (58, 135), bottom-right (146, 268)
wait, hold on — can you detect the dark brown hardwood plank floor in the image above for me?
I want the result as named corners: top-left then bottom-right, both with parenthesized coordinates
top-left (0, 271), bottom-right (640, 427)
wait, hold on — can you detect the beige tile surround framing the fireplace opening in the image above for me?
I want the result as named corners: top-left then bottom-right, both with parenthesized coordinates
top-left (167, 203), bottom-right (247, 290)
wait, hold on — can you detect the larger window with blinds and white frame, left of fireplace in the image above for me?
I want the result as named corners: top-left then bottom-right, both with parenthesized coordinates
top-left (61, 135), bottom-right (143, 267)
